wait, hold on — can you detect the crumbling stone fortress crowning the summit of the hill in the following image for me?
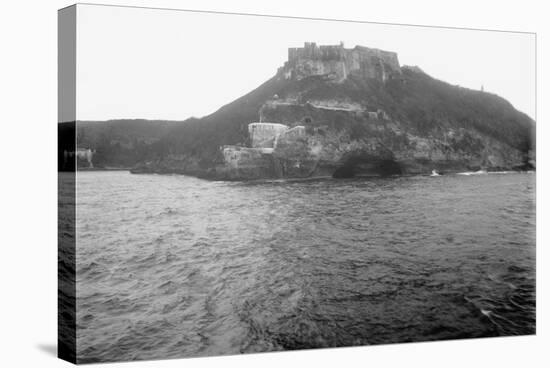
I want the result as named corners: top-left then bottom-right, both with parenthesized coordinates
top-left (279, 42), bottom-right (401, 82)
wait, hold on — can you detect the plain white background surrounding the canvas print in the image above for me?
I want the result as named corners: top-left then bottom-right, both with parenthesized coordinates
top-left (0, 0), bottom-right (550, 368)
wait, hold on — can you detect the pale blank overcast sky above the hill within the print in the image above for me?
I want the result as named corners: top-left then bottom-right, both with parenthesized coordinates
top-left (77, 5), bottom-right (535, 120)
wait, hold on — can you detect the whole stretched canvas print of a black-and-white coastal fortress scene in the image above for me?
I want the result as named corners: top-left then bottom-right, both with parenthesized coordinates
top-left (58, 5), bottom-right (536, 363)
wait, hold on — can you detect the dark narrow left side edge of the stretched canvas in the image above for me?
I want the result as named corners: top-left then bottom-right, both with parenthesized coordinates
top-left (57, 5), bottom-right (77, 363)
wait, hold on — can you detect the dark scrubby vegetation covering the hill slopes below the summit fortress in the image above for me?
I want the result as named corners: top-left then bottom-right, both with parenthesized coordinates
top-left (72, 57), bottom-right (535, 172)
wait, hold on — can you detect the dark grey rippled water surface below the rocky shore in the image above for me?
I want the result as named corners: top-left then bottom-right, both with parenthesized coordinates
top-left (76, 172), bottom-right (535, 362)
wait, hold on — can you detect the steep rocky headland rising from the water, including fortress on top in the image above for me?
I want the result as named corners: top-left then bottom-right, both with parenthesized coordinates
top-left (129, 43), bottom-right (535, 180)
